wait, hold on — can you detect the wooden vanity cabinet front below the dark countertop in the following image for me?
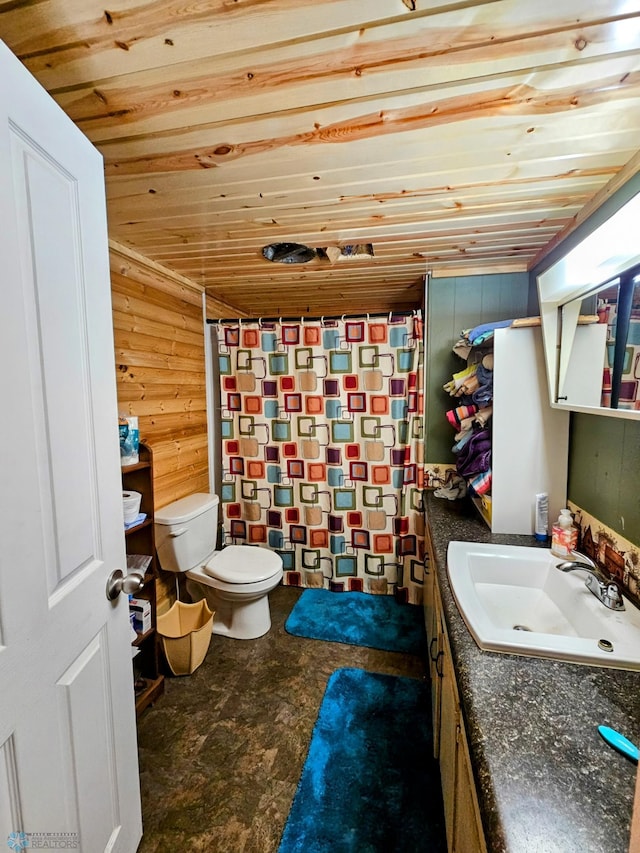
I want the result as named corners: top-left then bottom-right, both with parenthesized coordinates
top-left (424, 537), bottom-right (487, 853)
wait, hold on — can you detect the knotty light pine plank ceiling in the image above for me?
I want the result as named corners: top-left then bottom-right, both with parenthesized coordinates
top-left (0, 0), bottom-right (640, 316)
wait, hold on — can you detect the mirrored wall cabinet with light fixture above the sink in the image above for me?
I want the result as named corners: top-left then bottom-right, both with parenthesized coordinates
top-left (537, 194), bottom-right (640, 418)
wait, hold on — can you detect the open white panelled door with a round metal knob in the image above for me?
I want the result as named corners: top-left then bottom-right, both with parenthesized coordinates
top-left (0, 42), bottom-right (142, 853)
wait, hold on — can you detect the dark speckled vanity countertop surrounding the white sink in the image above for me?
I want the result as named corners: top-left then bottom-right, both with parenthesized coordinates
top-left (427, 493), bottom-right (640, 853)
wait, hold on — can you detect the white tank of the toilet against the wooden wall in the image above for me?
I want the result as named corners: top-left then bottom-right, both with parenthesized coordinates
top-left (155, 493), bottom-right (218, 572)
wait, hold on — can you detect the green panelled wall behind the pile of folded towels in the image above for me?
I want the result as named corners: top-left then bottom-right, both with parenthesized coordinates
top-left (425, 273), bottom-right (529, 463)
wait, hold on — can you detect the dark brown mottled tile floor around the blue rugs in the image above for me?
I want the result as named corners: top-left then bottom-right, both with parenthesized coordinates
top-left (138, 586), bottom-right (425, 853)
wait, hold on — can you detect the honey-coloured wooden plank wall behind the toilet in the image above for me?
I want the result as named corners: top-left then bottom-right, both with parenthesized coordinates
top-left (110, 242), bottom-right (240, 607)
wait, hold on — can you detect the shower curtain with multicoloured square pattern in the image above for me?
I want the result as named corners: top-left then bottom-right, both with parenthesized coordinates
top-left (218, 315), bottom-right (424, 604)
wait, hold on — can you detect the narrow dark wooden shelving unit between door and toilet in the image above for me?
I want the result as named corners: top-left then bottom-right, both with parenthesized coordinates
top-left (122, 444), bottom-right (164, 714)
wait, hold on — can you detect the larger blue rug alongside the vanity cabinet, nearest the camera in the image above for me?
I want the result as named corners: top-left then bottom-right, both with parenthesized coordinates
top-left (278, 669), bottom-right (447, 853)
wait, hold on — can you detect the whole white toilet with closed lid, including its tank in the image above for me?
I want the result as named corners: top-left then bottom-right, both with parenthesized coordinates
top-left (155, 494), bottom-right (282, 640)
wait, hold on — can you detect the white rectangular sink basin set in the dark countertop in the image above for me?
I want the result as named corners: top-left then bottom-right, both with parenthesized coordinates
top-left (447, 542), bottom-right (640, 670)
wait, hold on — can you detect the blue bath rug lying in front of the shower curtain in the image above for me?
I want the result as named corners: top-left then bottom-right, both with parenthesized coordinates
top-left (284, 589), bottom-right (426, 655)
